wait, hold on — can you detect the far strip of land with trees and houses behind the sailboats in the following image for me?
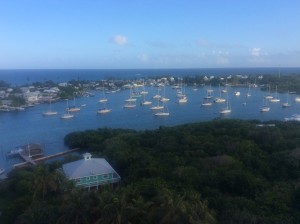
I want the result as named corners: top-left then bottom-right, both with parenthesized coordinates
top-left (0, 74), bottom-right (300, 111)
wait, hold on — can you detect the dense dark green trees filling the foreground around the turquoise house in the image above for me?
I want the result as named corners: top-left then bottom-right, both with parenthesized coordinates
top-left (0, 120), bottom-right (300, 224)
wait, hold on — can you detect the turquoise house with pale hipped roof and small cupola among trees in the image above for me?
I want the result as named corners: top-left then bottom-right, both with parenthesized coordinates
top-left (62, 153), bottom-right (121, 189)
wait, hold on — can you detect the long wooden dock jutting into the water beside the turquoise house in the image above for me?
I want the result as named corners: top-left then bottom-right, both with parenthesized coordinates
top-left (13, 148), bottom-right (79, 168)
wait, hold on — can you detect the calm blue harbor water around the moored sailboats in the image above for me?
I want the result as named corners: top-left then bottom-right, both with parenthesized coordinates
top-left (0, 67), bottom-right (300, 169)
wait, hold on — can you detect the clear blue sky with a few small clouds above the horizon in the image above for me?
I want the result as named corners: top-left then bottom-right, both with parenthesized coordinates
top-left (0, 0), bottom-right (300, 69)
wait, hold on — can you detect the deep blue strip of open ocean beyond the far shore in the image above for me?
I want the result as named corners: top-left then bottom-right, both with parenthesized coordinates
top-left (0, 68), bottom-right (300, 85)
